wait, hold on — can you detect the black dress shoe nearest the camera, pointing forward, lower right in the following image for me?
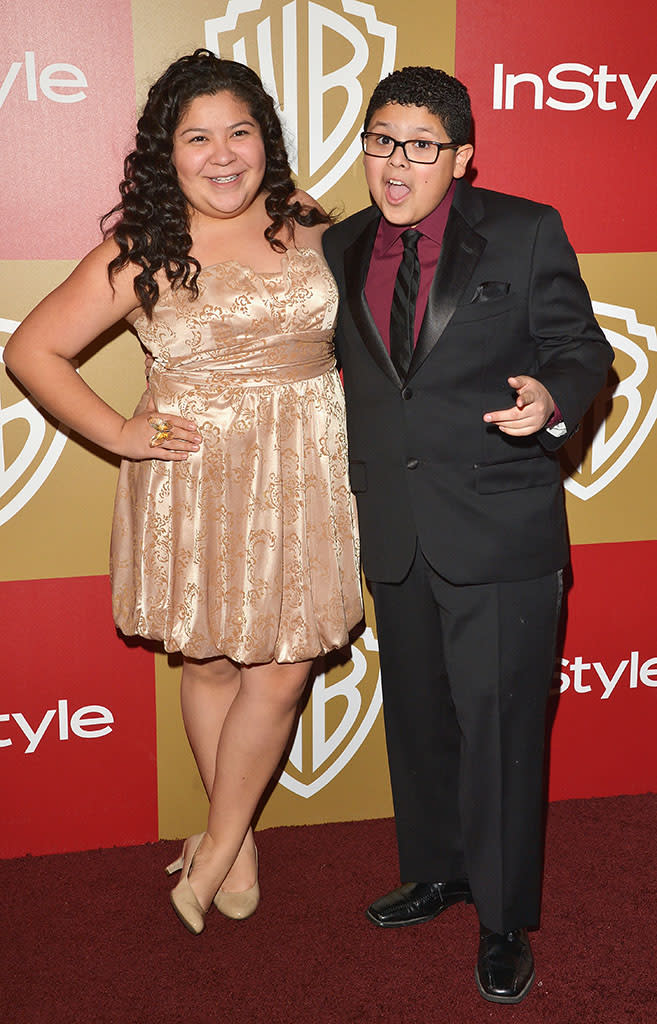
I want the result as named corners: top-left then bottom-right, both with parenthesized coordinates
top-left (475, 928), bottom-right (534, 1002)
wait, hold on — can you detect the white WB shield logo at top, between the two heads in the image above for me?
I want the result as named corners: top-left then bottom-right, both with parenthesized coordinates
top-left (205, 0), bottom-right (397, 199)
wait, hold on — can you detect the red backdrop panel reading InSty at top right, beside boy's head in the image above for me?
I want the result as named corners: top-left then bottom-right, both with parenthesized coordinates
top-left (455, 0), bottom-right (657, 253)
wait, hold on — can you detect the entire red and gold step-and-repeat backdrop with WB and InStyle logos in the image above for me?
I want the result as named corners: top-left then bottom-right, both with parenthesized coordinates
top-left (0, 0), bottom-right (657, 857)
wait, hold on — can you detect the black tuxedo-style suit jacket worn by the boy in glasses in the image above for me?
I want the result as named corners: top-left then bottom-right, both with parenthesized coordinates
top-left (324, 180), bottom-right (613, 583)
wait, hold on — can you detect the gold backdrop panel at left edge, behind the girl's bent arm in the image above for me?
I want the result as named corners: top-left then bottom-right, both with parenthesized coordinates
top-left (0, 260), bottom-right (144, 580)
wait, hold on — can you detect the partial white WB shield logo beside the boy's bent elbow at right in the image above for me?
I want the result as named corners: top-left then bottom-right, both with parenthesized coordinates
top-left (564, 302), bottom-right (657, 501)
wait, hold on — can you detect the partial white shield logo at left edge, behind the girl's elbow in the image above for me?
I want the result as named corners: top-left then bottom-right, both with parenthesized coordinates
top-left (0, 317), bottom-right (68, 525)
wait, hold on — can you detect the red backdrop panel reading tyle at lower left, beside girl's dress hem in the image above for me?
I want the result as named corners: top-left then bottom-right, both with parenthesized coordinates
top-left (0, 577), bottom-right (158, 857)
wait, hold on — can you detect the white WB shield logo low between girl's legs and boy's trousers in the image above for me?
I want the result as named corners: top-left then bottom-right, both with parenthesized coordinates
top-left (278, 627), bottom-right (382, 799)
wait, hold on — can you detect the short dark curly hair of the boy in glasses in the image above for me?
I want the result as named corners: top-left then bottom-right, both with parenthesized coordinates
top-left (365, 68), bottom-right (472, 145)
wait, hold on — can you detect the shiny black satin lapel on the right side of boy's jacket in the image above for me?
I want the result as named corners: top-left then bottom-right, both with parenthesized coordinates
top-left (406, 205), bottom-right (486, 379)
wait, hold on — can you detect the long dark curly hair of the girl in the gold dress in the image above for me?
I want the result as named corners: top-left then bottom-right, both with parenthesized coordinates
top-left (100, 49), bottom-right (331, 317)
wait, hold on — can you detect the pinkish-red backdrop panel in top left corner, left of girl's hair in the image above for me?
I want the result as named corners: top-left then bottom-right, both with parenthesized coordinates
top-left (0, 0), bottom-right (135, 259)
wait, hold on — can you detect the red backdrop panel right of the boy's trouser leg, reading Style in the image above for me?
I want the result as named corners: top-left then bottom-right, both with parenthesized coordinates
top-left (550, 541), bottom-right (657, 800)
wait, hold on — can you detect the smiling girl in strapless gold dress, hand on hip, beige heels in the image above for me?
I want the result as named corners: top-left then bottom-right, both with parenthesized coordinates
top-left (5, 50), bottom-right (362, 934)
